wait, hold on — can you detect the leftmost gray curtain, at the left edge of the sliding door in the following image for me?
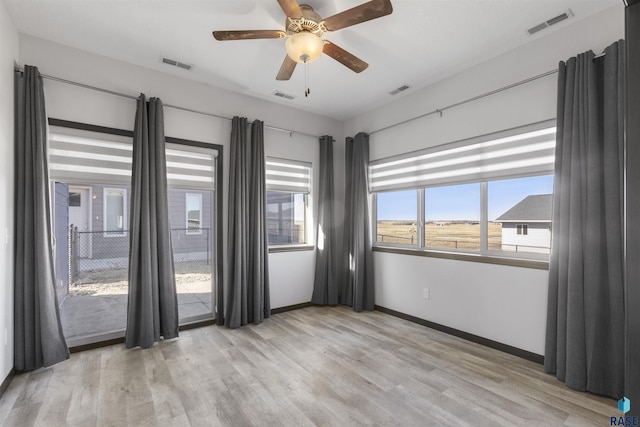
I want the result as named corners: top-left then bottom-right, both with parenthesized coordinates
top-left (14, 65), bottom-right (69, 371)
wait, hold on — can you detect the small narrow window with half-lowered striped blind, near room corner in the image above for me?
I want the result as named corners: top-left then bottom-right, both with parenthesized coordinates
top-left (266, 157), bottom-right (311, 245)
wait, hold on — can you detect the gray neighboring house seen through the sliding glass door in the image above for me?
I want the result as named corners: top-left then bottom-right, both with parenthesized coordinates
top-left (55, 183), bottom-right (214, 281)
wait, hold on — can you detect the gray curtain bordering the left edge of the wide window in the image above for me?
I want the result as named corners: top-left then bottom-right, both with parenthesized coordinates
top-left (340, 132), bottom-right (375, 311)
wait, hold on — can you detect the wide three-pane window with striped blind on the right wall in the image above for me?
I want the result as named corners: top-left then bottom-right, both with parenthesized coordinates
top-left (369, 121), bottom-right (555, 259)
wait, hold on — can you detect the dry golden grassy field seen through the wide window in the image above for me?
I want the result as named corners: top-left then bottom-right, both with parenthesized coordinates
top-left (376, 221), bottom-right (502, 250)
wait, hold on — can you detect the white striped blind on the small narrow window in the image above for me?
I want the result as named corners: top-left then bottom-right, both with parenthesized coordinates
top-left (266, 157), bottom-right (311, 194)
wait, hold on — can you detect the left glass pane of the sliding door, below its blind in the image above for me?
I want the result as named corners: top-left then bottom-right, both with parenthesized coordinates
top-left (54, 182), bottom-right (129, 345)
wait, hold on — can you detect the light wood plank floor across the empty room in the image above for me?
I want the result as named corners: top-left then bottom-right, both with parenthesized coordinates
top-left (0, 307), bottom-right (618, 426)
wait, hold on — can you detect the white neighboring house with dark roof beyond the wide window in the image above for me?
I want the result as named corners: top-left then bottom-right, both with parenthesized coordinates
top-left (495, 194), bottom-right (553, 254)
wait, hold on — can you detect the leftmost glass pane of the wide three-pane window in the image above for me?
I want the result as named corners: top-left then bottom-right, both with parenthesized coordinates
top-left (376, 190), bottom-right (418, 245)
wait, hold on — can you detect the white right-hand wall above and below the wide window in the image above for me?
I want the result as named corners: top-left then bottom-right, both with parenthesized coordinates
top-left (345, 2), bottom-right (624, 354)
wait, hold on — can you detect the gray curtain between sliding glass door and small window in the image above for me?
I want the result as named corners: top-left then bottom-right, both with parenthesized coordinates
top-left (225, 117), bottom-right (271, 328)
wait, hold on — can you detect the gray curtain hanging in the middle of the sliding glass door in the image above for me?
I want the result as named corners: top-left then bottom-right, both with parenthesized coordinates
top-left (125, 94), bottom-right (178, 348)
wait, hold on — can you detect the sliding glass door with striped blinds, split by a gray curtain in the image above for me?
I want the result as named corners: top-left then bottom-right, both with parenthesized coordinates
top-left (49, 126), bottom-right (218, 347)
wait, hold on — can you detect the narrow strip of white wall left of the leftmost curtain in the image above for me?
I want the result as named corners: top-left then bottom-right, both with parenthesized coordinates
top-left (0, 2), bottom-right (18, 383)
